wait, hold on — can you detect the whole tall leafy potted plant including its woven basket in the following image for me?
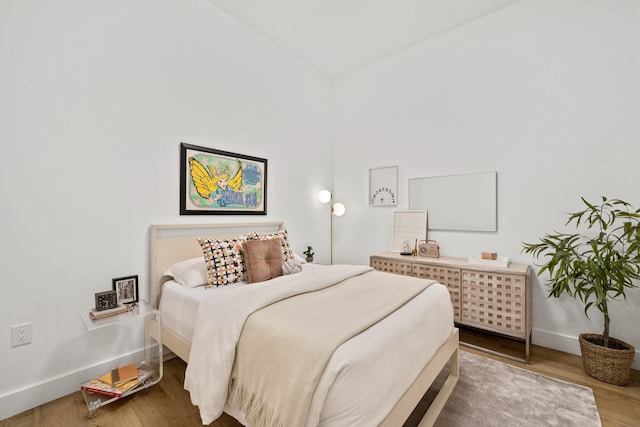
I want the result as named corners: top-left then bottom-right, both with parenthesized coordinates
top-left (523, 197), bottom-right (640, 385)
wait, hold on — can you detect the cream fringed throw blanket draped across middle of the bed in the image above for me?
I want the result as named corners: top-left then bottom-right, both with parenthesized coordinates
top-left (229, 271), bottom-right (434, 427)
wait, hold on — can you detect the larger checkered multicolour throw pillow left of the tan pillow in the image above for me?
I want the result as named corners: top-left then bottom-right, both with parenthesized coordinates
top-left (198, 235), bottom-right (247, 288)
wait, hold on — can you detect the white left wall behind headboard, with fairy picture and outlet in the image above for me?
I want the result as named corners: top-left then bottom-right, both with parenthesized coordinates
top-left (0, 0), bottom-right (333, 419)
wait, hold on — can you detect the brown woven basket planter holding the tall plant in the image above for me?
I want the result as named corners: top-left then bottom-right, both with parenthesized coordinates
top-left (579, 334), bottom-right (636, 385)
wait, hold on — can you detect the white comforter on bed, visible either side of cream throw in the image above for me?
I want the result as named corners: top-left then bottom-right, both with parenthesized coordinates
top-left (185, 265), bottom-right (453, 426)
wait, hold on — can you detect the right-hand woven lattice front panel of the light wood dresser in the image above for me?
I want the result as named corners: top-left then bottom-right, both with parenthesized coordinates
top-left (462, 270), bottom-right (526, 337)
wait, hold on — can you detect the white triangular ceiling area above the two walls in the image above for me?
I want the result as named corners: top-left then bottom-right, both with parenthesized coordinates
top-left (209, 0), bottom-right (521, 76)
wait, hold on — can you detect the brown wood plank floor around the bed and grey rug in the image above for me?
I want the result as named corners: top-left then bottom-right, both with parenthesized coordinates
top-left (0, 337), bottom-right (640, 427)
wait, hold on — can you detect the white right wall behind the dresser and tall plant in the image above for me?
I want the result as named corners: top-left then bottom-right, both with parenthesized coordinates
top-left (334, 0), bottom-right (640, 368)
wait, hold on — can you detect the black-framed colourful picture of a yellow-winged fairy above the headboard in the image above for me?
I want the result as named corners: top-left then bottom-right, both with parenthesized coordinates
top-left (180, 143), bottom-right (267, 215)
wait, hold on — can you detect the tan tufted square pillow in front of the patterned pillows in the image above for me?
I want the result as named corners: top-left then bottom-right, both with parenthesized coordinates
top-left (242, 239), bottom-right (284, 283)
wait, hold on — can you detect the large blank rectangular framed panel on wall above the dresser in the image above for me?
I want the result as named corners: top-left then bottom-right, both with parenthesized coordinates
top-left (409, 172), bottom-right (498, 231)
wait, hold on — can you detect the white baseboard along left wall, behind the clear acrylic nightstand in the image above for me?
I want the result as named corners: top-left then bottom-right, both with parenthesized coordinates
top-left (0, 351), bottom-right (144, 420)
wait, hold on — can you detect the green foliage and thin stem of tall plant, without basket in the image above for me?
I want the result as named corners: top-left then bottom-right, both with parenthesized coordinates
top-left (523, 197), bottom-right (640, 347)
